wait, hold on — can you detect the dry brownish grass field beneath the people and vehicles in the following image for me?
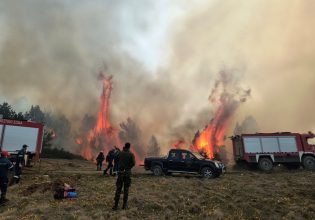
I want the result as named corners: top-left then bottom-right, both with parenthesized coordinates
top-left (0, 159), bottom-right (315, 220)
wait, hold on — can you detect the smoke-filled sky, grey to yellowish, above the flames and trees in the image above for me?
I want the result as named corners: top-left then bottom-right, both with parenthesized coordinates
top-left (0, 0), bottom-right (315, 153)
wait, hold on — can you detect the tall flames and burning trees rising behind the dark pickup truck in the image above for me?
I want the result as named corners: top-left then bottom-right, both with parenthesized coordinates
top-left (172, 69), bottom-right (251, 159)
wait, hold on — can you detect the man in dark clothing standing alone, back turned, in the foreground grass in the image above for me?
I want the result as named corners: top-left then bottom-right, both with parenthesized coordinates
top-left (112, 143), bottom-right (135, 210)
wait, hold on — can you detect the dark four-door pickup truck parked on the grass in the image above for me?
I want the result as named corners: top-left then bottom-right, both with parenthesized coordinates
top-left (144, 149), bottom-right (225, 178)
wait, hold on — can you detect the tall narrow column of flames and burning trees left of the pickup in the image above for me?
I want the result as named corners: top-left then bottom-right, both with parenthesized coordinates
top-left (76, 72), bottom-right (143, 163)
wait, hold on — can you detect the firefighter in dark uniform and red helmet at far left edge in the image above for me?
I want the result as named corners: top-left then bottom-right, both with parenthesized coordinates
top-left (0, 151), bottom-right (13, 205)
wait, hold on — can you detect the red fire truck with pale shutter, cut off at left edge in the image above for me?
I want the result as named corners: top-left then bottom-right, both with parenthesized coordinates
top-left (0, 119), bottom-right (44, 163)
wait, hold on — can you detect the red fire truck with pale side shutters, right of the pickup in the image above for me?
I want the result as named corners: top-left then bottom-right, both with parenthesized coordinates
top-left (231, 132), bottom-right (315, 171)
